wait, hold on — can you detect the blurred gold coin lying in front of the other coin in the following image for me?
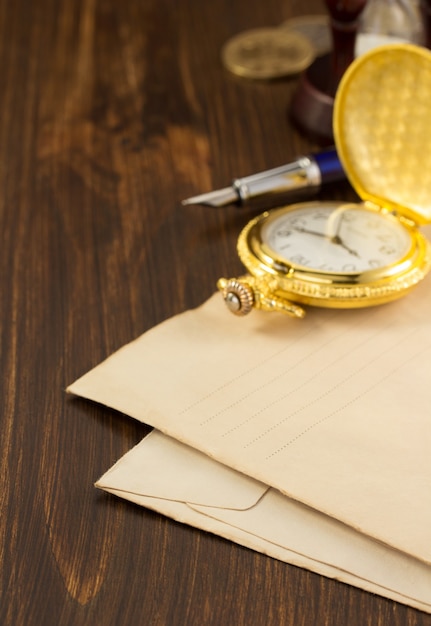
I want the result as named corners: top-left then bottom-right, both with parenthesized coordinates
top-left (221, 28), bottom-right (314, 79)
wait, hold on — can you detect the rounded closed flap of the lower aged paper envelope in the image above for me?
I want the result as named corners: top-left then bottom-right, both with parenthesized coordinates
top-left (96, 430), bottom-right (268, 510)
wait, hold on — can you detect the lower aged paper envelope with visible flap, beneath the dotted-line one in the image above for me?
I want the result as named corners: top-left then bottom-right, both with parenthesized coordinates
top-left (97, 430), bottom-right (431, 612)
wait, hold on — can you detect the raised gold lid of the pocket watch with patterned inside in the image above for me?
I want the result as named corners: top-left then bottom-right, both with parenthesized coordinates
top-left (334, 44), bottom-right (431, 224)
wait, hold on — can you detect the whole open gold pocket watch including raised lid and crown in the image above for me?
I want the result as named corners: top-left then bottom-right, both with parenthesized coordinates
top-left (218, 44), bottom-right (431, 317)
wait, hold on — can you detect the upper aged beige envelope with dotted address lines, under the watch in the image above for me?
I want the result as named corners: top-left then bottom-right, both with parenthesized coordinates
top-left (68, 270), bottom-right (431, 608)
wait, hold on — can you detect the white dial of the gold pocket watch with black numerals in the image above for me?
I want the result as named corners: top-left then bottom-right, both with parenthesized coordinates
top-left (260, 203), bottom-right (412, 274)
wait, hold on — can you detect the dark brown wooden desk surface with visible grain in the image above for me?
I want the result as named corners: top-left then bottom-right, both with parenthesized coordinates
top-left (0, 0), bottom-right (431, 626)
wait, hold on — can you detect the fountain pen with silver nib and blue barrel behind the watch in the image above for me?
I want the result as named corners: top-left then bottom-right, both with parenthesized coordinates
top-left (181, 148), bottom-right (346, 207)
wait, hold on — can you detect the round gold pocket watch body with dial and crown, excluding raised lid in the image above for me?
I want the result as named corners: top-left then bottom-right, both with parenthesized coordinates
top-left (223, 201), bottom-right (431, 317)
